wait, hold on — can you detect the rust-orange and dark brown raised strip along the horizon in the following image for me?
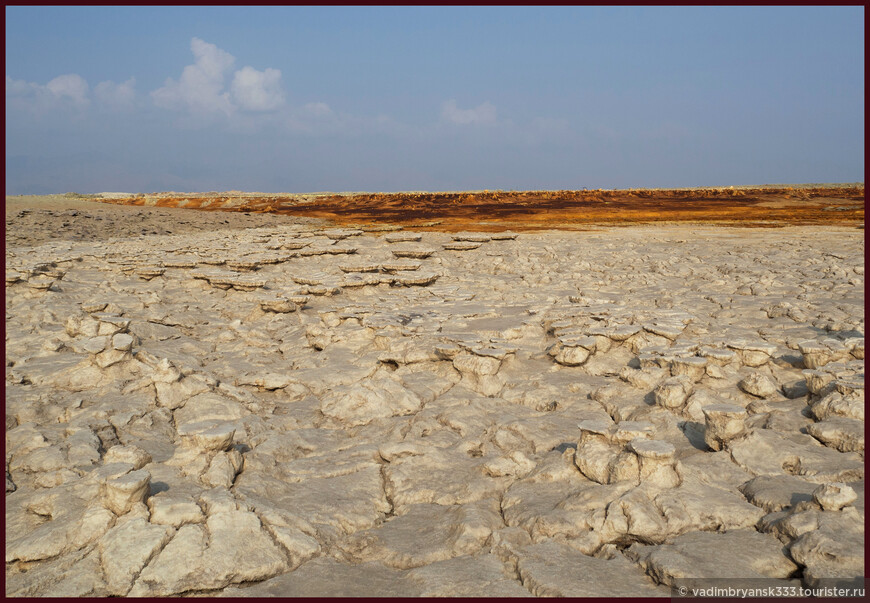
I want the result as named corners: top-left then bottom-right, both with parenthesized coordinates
top-left (97, 186), bottom-right (864, 232)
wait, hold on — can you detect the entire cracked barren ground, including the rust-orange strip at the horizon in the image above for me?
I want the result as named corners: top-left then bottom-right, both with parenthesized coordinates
top-left (5, 186), bottom-right (865, 597)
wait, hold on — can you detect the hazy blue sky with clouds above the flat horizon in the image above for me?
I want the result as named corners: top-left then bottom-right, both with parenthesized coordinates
top-left (6, 7), bottom-right (864, 194)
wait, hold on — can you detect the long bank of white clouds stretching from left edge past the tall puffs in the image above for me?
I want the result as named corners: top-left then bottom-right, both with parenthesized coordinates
top-left (6, 37), bottom-right (509, 136)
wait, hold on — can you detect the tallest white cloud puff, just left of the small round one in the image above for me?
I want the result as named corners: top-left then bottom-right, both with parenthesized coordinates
top-left (151, 38), bottom-right (235, 115)
